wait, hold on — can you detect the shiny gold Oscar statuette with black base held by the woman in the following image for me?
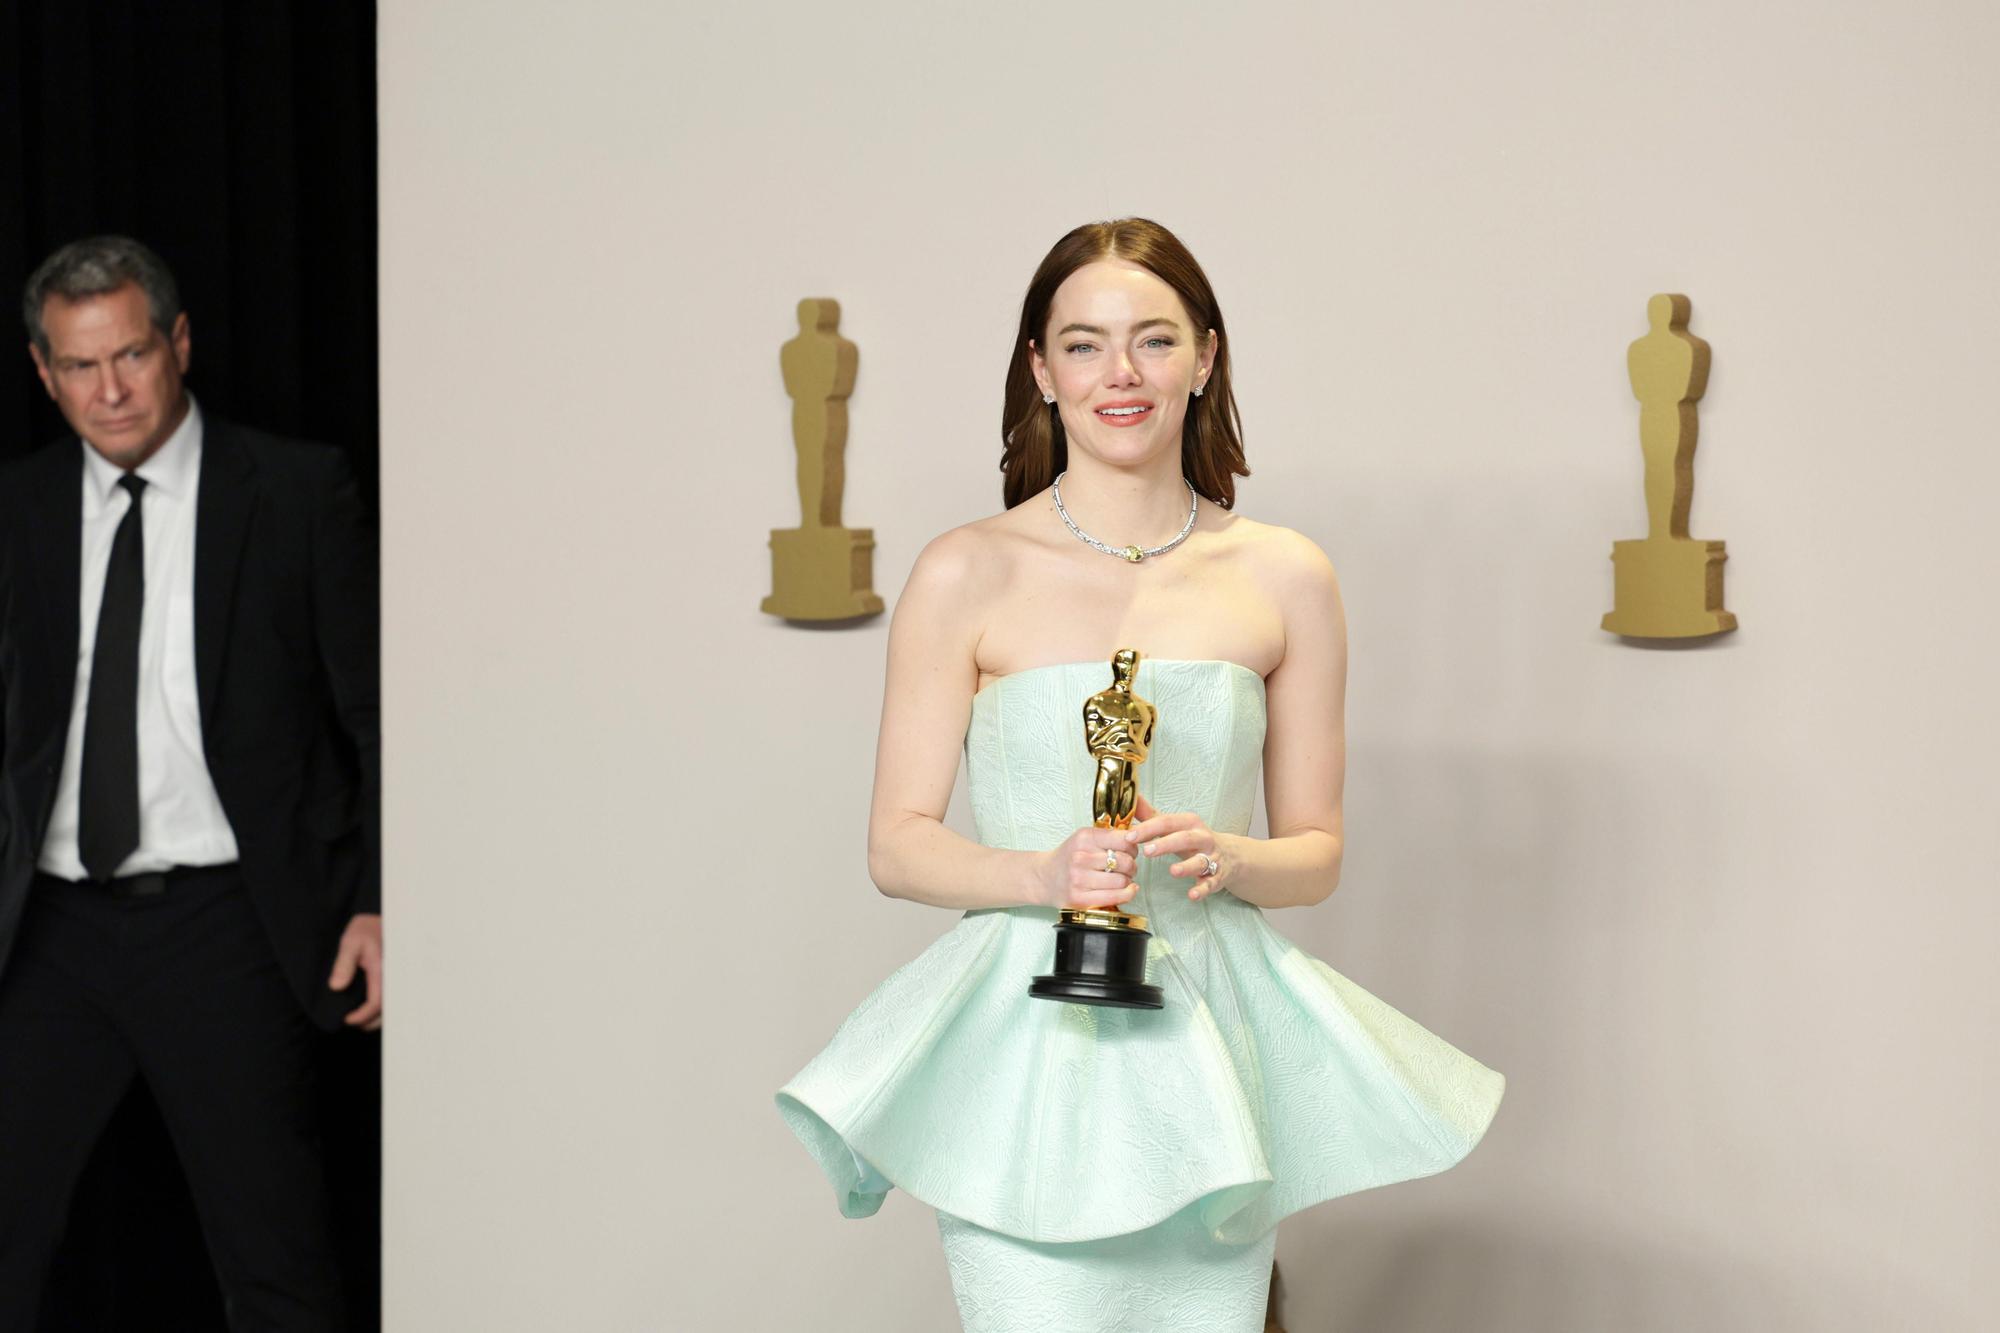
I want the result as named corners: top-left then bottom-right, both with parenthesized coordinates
top-left (1028, 648), bottom-right (1166, 1009)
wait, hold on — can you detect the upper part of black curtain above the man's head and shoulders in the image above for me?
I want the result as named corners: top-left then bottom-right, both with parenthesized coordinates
top-left (0, 0), bottom-right (378, 498)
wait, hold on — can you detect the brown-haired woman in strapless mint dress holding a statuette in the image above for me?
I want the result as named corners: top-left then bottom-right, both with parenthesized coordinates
top-left (778, 218), bottom-right (1504, 1333)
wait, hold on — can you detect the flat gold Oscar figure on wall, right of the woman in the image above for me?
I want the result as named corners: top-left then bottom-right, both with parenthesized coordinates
top-left (1604, 294), bottom-right (1736, 638)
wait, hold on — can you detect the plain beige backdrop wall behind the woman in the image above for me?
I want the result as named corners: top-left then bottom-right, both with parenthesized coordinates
top-left (380, 0), bottom-right (2000, 1333)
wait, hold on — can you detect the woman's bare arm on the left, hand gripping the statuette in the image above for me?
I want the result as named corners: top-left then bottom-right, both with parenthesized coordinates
top-left (868, 528), bottom-right (1134, 911)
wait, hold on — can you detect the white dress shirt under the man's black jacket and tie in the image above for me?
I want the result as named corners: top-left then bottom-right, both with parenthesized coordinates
top-left (38, 398), bottom-right (236, 879)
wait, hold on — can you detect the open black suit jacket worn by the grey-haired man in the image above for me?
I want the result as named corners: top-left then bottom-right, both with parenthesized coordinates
top-left (0, 416), bottom-right (382, 1027)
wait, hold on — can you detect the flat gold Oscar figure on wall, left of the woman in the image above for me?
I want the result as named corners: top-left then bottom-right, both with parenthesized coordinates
top-left (764, 298), bottom-right (882, 620)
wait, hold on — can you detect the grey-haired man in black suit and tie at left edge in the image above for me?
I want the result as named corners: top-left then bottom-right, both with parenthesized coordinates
top-left (0, 236), bottom-right (382, 1331)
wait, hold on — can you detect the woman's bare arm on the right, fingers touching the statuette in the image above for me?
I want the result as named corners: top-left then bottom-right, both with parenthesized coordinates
top-left (1134, 530), bottom-right (1348, 907)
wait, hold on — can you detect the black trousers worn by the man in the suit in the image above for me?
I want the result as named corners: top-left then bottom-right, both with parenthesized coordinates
top-left (0, 867), bottom-right (344, 1333)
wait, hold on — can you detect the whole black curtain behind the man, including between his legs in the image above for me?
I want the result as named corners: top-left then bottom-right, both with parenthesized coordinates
top-left (0, 0), bottom-right (380, 1333)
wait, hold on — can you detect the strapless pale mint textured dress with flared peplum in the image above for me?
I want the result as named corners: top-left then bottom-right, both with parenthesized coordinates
top-left (778, 658), bottom-right (1506, 1333)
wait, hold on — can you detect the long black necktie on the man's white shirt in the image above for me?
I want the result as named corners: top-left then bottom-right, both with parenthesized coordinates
top-left (76, 472), bottom-right (146, 883)
